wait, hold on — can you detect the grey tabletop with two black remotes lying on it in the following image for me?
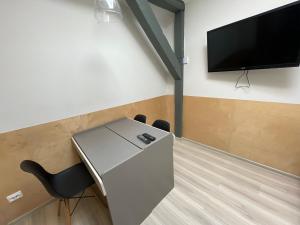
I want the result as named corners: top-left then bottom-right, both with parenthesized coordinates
top-left (73, 118), bottom-right (170, 176)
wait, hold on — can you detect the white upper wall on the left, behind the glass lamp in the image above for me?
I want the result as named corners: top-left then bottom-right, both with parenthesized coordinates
top-left (0, 0), bottom-right (172, 133)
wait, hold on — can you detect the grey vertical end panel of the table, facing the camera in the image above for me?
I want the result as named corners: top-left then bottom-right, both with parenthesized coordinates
top-left (102, 134), bottom-right (174, 225)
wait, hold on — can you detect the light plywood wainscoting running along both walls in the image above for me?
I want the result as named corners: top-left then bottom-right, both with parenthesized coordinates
top-left (0, 96), bottom-right (300, 225)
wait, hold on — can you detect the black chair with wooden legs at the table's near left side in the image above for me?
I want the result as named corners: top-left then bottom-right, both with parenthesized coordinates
top-left (20, 160), bottom-right (95, 225)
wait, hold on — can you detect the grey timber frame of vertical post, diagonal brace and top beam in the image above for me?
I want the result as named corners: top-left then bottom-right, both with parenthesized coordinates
top-left (126, 0), bottom-right (185, 137)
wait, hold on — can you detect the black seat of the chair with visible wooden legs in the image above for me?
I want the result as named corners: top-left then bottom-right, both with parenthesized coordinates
top-left (52, 163), bottom-right (94, 198)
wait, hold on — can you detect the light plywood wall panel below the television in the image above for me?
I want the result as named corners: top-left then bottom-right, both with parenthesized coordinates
top-left (182, 96), bottom-right (300, 176)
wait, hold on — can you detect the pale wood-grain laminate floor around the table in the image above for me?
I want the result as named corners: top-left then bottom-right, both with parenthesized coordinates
top-left (9, 140), bottom-right (300, 225)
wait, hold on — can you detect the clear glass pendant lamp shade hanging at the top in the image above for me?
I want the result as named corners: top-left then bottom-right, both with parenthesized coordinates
top-left (95, 0), bottom-right (123, 23)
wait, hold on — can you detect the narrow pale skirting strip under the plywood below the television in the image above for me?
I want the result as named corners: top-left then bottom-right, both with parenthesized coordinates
top-left (178, 137), bottom-right (300, 180)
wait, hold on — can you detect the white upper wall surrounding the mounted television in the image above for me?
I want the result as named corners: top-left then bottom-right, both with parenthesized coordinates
top-left (182, 0), bottom-right (300, 104)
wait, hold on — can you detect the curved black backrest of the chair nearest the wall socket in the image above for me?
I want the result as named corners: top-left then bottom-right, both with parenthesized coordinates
top-left (20, 160), bottom-right (61, 198)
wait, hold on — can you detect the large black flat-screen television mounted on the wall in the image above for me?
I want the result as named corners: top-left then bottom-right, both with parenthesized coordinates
top-left (207, 1), bottom-right (300, 72)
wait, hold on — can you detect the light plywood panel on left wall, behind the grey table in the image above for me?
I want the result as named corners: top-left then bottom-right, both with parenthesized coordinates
top-left (0, 96), bottom-right (167, 225)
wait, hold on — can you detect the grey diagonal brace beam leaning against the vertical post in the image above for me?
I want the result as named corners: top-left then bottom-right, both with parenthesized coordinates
top-left (126, 0), bottom-right (182, 80)
